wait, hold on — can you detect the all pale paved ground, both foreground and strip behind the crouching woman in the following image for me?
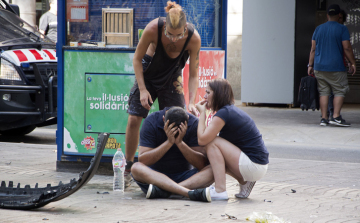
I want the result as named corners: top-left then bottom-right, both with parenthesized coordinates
top-left (0, 106), bottom-right (360, 223)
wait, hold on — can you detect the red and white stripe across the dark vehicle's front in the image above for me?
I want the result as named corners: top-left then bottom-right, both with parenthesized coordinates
top-left (2, 49), bottom-right (57, 66)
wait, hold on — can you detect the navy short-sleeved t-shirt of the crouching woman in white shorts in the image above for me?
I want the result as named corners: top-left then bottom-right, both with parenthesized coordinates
top-left (215, 105), bottom-right (269, 165)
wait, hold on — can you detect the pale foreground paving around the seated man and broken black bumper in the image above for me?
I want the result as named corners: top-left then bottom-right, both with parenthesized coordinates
top-left (0, 140), bottom-right (360, 223)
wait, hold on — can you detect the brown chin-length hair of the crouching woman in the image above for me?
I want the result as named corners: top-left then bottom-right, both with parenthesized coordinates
top-left (208, 78), bottom-right (235, 111)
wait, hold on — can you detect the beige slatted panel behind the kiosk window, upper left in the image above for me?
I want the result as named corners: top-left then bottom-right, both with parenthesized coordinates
top-left (102, 8), bottom-right (134, 47)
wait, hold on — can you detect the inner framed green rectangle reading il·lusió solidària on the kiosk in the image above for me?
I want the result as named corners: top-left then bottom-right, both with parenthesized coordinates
top-left (84, 73), bottom-right (135, 134)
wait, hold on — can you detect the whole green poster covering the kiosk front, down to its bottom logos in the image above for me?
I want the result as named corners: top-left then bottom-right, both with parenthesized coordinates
top-left (63, 51), bottom-right (159, 156)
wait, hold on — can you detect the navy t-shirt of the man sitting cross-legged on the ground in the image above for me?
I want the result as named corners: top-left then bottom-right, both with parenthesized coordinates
top-left (140, 108), bottom-right (199, 174)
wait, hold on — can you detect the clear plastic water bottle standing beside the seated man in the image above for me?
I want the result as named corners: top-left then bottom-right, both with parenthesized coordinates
top-left (113, 148), bottom-right (126, 192)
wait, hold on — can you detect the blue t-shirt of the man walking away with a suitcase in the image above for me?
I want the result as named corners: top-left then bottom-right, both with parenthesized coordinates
top-left (312, 21), bottom-right (350, 72)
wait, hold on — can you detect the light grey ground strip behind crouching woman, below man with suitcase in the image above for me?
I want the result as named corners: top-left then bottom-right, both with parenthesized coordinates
top-left (236, 101), bottom-right (360, 147)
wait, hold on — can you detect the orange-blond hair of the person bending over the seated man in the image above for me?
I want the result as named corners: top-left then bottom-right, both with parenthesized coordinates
top-left (165, 1), bottom-right (186, 29)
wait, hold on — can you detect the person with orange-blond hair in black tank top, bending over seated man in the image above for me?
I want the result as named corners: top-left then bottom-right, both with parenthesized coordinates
top-left (125, 1), bottom-right (201, 186)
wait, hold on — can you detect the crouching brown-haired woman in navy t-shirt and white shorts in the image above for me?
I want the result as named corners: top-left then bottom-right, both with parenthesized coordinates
top-left (196, 79), bottom-right (269, 200)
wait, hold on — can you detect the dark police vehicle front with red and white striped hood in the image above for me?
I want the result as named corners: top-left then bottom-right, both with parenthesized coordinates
top-left (0, 0), bottom-right (57, 135)
